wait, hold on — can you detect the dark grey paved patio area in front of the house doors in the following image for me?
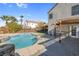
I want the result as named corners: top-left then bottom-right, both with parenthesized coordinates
top-left (40, 37), bottom-right (79, 56)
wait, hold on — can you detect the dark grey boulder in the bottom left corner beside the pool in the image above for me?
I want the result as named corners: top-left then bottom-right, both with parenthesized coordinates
top-left (0, 44), bottom-right (15, 56)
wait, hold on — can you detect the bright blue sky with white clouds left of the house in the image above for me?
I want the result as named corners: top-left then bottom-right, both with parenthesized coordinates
top-left (0, 3), bottom-right (55, 26)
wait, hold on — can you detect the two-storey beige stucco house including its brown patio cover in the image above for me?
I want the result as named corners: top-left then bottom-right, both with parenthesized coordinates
top-left (48, 3), bottom-right (79, 37)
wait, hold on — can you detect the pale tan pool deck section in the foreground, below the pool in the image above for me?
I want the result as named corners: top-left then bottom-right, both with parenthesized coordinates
top-left (16, 44), bottom-right (46, 56)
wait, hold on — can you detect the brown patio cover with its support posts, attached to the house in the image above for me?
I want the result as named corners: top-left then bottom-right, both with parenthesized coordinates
top-left (54, 16), bottom-right (79, 34)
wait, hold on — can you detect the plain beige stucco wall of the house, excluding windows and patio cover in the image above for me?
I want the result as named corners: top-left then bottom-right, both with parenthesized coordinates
top-left (48, 3), bottom-right (79, 34)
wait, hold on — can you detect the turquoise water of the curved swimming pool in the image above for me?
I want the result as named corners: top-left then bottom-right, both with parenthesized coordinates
top-left (8, 34), bottom-right (37, 49)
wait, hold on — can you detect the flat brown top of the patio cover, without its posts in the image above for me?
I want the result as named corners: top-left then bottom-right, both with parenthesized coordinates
top-left (56, 16), bottom-right (79, 25)
